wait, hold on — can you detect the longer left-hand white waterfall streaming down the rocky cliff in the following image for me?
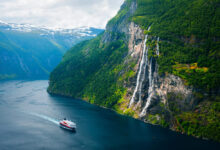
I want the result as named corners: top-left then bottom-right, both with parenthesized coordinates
top-left (128, 27), bottom-right (150, 107)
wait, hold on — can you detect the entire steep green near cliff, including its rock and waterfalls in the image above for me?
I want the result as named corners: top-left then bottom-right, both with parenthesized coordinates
top-left (48, 0), bottom-right (220, 141)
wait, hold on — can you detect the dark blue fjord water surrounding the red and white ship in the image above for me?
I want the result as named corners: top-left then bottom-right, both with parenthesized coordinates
top-left (0, 80), bottom-right (220, 150)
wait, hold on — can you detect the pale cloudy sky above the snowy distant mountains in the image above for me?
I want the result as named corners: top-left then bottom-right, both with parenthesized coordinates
top-left (0, 0), bottom-right (124, 28)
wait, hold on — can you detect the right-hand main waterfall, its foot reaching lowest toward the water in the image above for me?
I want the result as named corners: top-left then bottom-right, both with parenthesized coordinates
top-left (140, 58), bottom-right (154, 117)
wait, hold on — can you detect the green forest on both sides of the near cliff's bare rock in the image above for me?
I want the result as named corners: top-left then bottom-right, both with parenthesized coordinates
top-left (48, 0), bottom-right (220, 141)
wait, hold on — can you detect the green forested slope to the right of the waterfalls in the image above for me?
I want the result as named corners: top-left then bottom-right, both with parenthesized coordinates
top-left (132, 0), bottom-right (220, 141)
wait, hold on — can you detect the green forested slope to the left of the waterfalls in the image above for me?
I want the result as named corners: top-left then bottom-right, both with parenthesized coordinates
top-left (48, 34), bottom-right (131, 107)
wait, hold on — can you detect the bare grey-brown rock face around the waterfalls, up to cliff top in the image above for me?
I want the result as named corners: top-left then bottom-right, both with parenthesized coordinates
top-left (99, 1), bottom-right (195, 126)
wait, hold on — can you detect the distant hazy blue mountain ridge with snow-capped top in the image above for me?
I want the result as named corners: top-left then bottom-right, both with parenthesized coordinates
top-left (0, 22), bottom-right (103, 80)
